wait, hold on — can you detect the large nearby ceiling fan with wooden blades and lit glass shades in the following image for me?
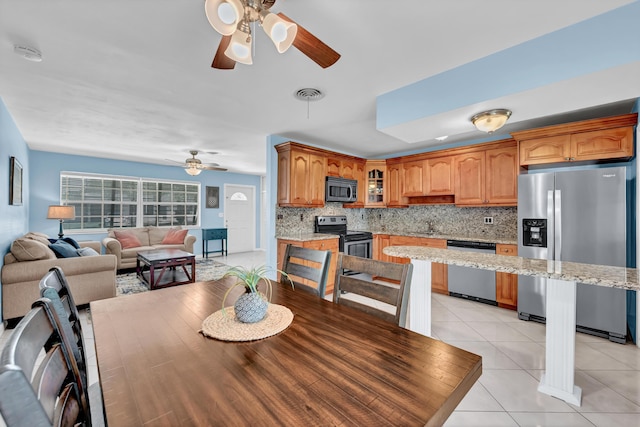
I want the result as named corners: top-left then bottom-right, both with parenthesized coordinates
top-left (204, 0), bottom-right (340, 70)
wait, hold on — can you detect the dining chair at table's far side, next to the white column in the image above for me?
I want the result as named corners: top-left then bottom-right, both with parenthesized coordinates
top-left (333, 253), bottom-right (413, 327)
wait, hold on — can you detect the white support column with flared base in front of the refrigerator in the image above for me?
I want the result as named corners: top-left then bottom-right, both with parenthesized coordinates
top-left (538, 279), bottom-right (582, 406)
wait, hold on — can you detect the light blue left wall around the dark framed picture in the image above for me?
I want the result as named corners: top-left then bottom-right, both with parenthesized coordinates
top-left (0, 98), bottom-right (31, 320)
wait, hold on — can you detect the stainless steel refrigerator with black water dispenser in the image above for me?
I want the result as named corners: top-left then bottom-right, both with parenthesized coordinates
top-left (518, 167), bottom-right (627, 343)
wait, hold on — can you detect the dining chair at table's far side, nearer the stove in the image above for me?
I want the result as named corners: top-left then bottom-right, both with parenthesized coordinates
top-left (280, 244), bottom-right (331, 298)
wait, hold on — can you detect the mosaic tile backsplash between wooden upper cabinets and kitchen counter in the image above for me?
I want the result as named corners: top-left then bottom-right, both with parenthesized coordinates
top-left (276, 203), bottom-right (518, 239)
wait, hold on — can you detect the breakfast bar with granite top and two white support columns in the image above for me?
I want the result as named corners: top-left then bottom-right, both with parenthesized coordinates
top-left (383, 246), bottom-right (640, 406)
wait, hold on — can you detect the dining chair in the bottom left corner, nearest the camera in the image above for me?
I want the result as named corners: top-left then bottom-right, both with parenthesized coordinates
top-left (0, 299), bottom-right (90, 427)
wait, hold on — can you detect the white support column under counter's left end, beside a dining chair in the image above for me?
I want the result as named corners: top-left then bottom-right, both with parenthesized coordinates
top-left (406, 259), bottom-right (431, 337)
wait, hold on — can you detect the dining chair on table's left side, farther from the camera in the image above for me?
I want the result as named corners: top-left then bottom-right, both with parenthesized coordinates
top-left (39, 267), bottom-right (105, 426)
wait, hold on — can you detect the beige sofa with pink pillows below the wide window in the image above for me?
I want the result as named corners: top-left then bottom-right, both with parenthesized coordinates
top-left (102, 227), bottom-right (196, 270)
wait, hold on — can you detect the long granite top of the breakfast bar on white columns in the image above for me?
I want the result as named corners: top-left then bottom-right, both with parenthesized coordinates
top-left (383, 246), bottom-right (640, 291)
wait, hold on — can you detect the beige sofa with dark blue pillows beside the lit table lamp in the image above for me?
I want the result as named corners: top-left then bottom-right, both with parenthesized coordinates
top-left (0, 233), bottom-right (116, 320)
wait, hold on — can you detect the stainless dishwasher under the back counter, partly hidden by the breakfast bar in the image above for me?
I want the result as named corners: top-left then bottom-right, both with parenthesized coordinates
top-left (447, 240), bottom-right (498, 305)
